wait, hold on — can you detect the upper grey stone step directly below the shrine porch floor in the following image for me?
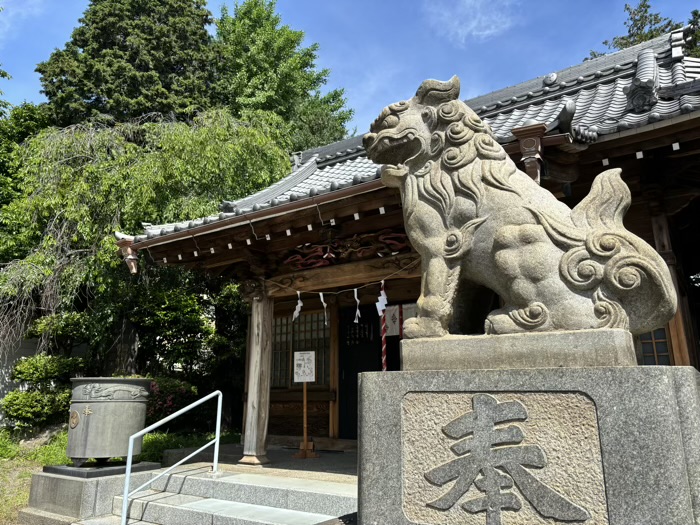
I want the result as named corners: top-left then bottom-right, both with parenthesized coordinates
top-left (150, 469), bottom-right (357, 516)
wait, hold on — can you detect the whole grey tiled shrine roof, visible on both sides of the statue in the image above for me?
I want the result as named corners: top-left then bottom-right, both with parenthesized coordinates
top-left (134, 30), bottom-right (700, 243)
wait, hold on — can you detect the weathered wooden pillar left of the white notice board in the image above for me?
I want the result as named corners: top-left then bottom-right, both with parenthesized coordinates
top-left (239, 281), bottom-right (274, 465)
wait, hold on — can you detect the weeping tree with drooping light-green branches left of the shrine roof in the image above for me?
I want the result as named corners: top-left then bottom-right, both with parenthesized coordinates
top-left (0, 110), bottom-right (289, 373)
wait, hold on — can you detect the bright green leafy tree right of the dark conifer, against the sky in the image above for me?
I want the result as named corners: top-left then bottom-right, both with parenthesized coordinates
top-left (212, 0), bottom-right (352, 150)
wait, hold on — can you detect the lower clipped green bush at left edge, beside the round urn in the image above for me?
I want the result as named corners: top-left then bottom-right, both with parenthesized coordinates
top-left (0, 388), bottom-right (71, 429)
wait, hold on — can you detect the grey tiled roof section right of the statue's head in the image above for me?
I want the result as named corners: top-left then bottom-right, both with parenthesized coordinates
top-left (476, 30), bottom-right (700, 143)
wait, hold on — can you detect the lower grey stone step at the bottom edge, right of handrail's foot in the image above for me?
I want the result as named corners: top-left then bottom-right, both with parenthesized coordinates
top-left (113, 490), bottom-right (334, 525)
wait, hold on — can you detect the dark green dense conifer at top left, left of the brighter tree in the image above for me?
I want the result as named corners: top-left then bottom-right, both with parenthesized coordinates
top-left (36, 0), bottom-right (212, 125)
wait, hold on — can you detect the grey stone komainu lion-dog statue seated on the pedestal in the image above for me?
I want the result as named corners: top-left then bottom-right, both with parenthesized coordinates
top-left (364, 77), bottom-right (676, 337)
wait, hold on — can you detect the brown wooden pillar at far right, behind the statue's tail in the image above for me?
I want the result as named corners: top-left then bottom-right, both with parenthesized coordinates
top-left (651, 206), bottom-right (691, 366)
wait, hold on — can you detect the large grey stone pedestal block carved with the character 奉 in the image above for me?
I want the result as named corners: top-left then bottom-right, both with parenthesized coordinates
top-left (359, 367), bottom-right (700, 525)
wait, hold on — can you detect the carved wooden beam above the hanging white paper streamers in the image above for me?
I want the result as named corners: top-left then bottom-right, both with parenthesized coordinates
top-left (266, 253), bottom-right (421, 297)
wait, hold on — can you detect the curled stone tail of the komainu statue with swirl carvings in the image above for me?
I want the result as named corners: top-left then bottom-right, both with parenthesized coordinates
top-left (531, 169), bottom-right (677, 334)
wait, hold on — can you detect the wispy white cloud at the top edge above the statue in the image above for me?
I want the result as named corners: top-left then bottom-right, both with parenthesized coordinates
top-left (423, 0), bottom-right (520, 45)
